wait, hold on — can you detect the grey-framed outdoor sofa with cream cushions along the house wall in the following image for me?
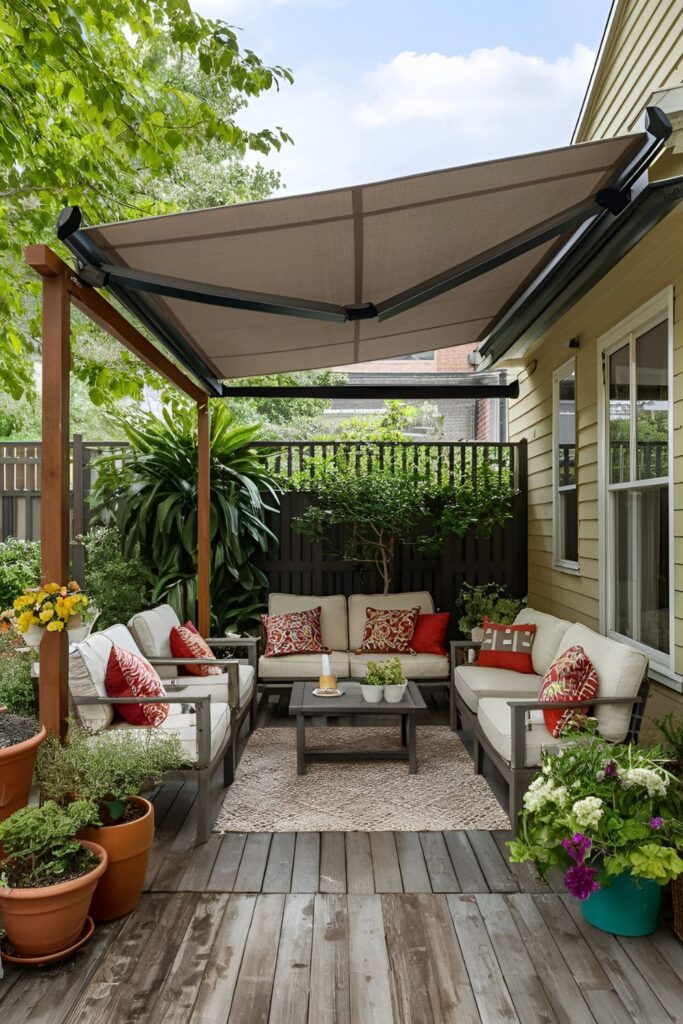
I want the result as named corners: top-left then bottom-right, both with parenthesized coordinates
top-left (451, 608), bottom-right (649, 830)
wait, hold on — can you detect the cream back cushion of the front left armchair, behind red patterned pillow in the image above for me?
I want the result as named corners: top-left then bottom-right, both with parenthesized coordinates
top-left (69, 626), bottom-right (140, 732)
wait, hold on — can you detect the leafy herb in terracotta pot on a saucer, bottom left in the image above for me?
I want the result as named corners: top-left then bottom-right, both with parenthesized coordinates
top-left (0, 801), bottom-right (106, 962)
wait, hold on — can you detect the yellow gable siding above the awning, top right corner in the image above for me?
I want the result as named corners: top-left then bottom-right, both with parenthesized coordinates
top-left (575, 0), bottom-right (683, 142)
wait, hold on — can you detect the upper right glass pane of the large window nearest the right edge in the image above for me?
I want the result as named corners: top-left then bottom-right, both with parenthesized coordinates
top-left (636, 321), bottom-right (669, 480)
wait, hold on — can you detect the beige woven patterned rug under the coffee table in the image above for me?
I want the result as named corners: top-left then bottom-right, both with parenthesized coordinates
top-left (214, 726), bottom-right (510, 833)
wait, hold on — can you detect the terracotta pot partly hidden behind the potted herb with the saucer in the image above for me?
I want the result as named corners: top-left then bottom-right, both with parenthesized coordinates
top-left (82, 797), bottom-right (155, 921)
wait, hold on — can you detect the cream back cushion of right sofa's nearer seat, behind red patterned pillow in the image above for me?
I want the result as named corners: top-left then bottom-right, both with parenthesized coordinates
top-left (561, 623), bottom-right (647, 743)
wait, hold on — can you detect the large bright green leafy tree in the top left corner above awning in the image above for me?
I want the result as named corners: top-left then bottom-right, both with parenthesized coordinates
top-left (0, 0), bottom-right (292, 397)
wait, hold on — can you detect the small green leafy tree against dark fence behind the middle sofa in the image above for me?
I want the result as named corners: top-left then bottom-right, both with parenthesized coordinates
top-left (293, 445), bottom-right (515, 594)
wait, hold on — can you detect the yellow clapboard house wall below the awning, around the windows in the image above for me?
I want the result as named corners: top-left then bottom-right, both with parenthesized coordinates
top-left (502, 210), bottom-right (683, 735)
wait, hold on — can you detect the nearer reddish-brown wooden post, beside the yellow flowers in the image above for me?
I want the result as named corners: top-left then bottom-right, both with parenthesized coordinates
top-left (38, 273), bottom-right (71, 736)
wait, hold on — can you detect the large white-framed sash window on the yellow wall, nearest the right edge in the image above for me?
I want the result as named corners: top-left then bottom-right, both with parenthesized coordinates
top-left (602, 297), bottom-right (673, 669)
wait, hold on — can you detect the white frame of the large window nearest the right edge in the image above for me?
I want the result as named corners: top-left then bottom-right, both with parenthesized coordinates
top-left (597, 286), bottom-right (682, 691)
